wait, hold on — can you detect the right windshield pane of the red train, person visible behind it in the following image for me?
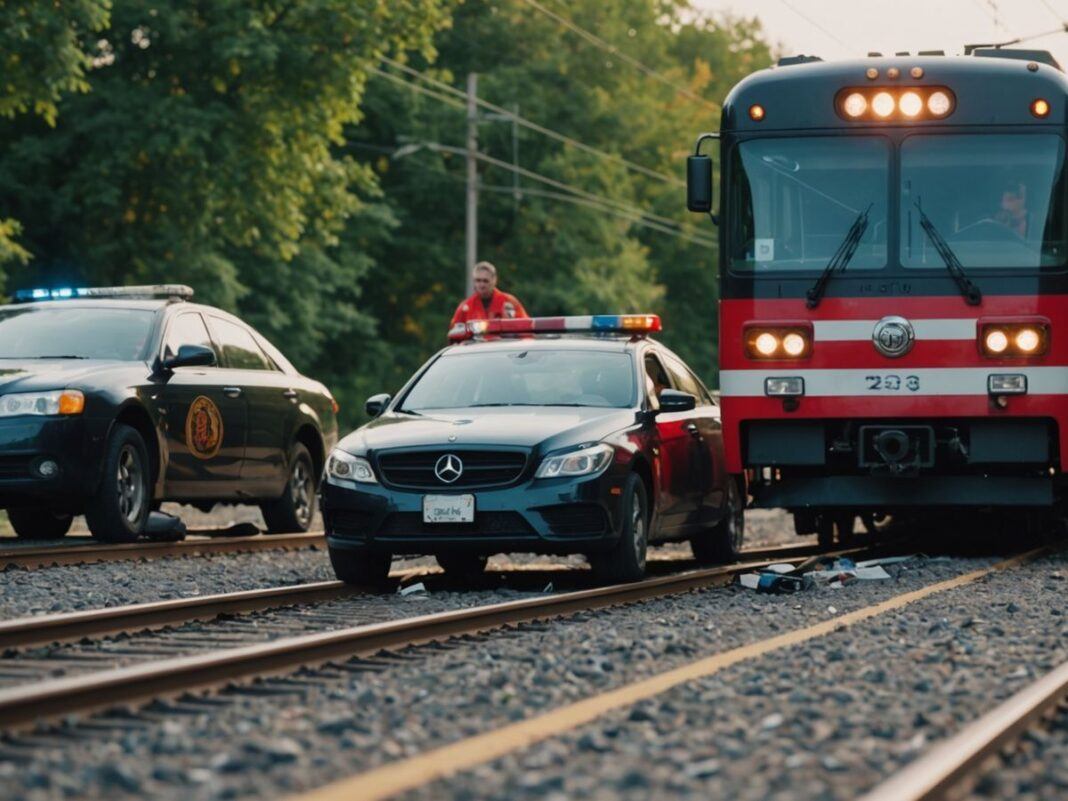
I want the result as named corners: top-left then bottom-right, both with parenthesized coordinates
top-left (901, 134), bottom-right (1066, 268)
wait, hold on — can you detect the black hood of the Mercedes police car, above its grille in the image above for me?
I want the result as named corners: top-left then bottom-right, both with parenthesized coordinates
top-left (339, 406), bottom-right (634, 455)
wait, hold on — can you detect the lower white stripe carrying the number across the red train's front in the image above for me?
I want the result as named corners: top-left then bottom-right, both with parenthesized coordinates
top-left (720, 365), bottom-right (1068, 397)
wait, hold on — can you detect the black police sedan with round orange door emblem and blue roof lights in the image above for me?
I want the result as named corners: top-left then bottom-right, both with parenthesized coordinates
top-left (0, 285), bottom-right (337, 541)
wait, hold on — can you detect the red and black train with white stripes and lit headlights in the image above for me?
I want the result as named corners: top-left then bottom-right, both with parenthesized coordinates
top-left (687, 47), bottom-right (1068, 541)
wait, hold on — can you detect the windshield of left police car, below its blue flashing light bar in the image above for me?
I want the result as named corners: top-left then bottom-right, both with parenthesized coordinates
top-left (0, 307), bottom-right (154, 361)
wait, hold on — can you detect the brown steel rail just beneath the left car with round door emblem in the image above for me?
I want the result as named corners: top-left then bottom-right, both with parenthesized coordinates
top-left (0, 532), bottom-right (326, 570)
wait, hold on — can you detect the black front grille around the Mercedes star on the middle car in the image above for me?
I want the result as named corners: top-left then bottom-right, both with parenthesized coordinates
top-left (378, 451), bottom-right (527, 489)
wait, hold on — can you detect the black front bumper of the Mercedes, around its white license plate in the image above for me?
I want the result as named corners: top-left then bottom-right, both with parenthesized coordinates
top-left (320, 466), bottom-right (627, 554)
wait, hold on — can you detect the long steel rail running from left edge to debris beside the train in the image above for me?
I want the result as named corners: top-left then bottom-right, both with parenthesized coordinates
top-left (0, 556), bottom-right (837, 729)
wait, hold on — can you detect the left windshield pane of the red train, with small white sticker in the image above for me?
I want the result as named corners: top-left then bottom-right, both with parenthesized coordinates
top-left (731, 137), bottom-right (890, 272)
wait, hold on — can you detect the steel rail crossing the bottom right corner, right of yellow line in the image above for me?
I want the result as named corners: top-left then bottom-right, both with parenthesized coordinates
top-left (861, 662), bottom-right (1068, 801)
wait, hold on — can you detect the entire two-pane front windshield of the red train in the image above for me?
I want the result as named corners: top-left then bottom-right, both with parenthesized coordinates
top-left (728, 134), bottom-right (1068, 273)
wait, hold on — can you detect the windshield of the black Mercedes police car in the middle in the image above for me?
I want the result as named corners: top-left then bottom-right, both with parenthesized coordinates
top-left (402, 348), bottom-right (637, 411)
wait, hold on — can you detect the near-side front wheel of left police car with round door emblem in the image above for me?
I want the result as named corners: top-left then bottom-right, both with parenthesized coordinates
top-left (85, 423), bottom-right (152, 543)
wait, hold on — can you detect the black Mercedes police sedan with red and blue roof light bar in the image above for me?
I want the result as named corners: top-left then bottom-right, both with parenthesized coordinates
top-left (321, 315), bottom-right (743, 583)
